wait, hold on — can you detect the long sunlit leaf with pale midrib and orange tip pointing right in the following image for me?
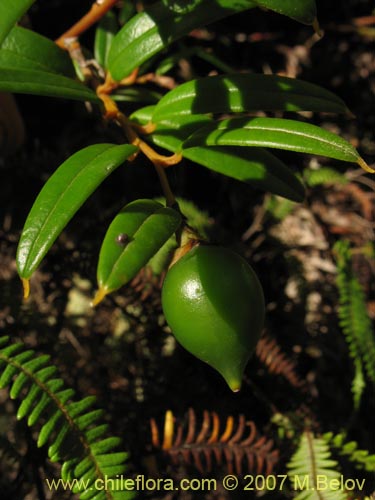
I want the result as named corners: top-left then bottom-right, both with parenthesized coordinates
top-left (183, 117), bottom-right (368, 163)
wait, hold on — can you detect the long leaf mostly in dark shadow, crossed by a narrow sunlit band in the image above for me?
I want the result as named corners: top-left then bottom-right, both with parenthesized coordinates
top-left (152, 74), bottom-right (350, 123)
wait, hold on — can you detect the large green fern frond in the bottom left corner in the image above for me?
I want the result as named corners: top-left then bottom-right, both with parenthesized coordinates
top-left (0, 337), bottom-right (133, 500)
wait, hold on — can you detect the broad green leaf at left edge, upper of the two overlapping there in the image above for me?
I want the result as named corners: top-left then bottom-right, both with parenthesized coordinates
top-left (0, 26), bottom-right (74, 77)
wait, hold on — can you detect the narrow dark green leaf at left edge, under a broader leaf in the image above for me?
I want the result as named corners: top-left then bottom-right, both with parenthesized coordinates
top-left (0, 68), bottom-right (100, 102)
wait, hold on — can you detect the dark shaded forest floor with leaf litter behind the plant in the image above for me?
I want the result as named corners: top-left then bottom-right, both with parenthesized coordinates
top-left (0, 1), bottom-right (375, 500)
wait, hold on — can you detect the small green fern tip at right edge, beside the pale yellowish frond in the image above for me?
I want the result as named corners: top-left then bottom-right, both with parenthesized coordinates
top-left (322, 432), bottom-right (375, 472)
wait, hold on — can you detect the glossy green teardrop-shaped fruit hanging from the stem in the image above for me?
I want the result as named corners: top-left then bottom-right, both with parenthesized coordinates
top-left (162, 246), bottom-right (264, 391)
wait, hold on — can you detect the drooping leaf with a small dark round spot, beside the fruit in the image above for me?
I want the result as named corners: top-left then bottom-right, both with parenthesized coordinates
top-left (93, 200), bottom-right (181, 305)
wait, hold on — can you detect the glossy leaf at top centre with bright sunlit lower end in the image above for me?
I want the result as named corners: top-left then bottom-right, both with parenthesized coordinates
top-left (108, 0), bottom-right (255, 80)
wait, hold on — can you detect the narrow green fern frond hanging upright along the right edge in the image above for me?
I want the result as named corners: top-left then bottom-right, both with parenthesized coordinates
top-left (334, 241), bottom-right (375, 405)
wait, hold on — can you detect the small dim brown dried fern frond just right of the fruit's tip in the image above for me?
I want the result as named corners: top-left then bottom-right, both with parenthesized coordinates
top-left (255, 335), bottom-right (306, 390)
